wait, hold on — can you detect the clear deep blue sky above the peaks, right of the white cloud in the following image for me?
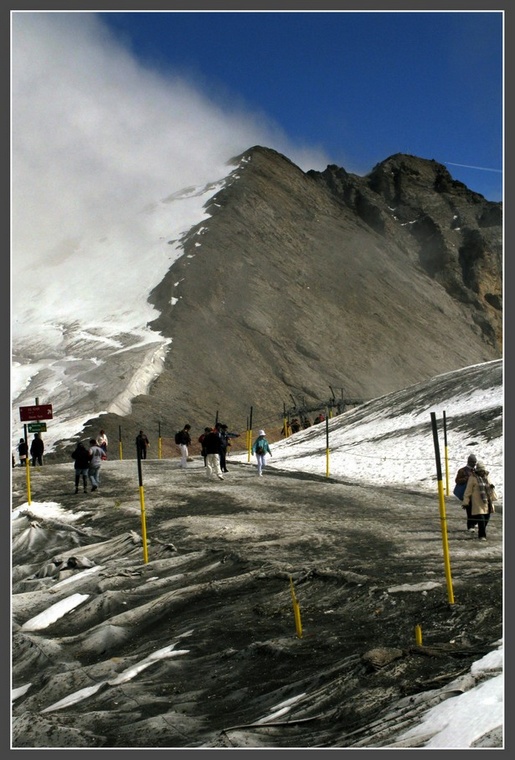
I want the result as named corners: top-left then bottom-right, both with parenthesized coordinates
top-left (99, 11), bottom-right (503, 200)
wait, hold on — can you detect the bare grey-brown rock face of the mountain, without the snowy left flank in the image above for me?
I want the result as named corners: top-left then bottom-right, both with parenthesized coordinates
top-left (78, 147), bottom-right (502, 446)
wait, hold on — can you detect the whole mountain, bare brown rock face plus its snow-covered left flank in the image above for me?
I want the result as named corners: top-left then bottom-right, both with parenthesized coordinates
top-left (20, 146), bottom-right (503, 446)
